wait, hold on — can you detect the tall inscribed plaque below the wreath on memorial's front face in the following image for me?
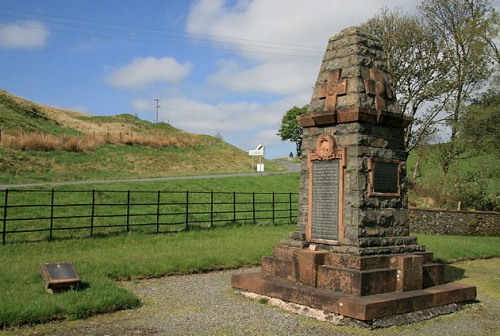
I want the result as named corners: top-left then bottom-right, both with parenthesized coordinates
top-left (310, 160), bottom-right (340, 240)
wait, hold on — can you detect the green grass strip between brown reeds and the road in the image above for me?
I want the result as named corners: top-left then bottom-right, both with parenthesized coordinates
top-left (0, 143), bottom-right (283, 184)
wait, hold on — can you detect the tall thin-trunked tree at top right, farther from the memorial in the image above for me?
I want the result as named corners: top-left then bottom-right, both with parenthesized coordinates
top-left (419, 0), bottom-right (498, 175)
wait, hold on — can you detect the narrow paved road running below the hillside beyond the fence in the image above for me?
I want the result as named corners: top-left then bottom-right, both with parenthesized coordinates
top-left (0, 160), bottom-right (300, 190)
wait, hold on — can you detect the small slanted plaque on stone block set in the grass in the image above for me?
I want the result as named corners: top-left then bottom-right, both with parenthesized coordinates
top-left (40, 263), bottom-right (80, 292)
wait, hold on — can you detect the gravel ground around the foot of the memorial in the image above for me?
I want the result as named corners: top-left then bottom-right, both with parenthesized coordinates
top-left (0, 262), bottom-right (500, 336)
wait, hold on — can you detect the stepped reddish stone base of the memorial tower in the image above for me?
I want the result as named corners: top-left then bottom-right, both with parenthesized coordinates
top-left (231, 247), bottom-right (476, 321)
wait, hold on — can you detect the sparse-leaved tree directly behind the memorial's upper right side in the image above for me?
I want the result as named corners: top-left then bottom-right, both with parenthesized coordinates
top-left (362, 8), bottom-right (448, 152)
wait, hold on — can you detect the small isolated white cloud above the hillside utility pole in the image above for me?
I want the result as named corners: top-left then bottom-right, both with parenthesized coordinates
top-left (106, 57), bottom-right (192, 88)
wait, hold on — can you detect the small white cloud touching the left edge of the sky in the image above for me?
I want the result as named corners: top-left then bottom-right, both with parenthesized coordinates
top-left (0, 20), bottom-right (49, 49)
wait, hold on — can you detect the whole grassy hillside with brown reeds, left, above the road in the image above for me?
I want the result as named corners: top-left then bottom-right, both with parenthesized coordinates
top-left (0, 90), bottom-right (282, 184)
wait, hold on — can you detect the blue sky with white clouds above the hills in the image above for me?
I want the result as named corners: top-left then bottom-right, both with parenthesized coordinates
top-left (0, 0), bottom-right (442, 158)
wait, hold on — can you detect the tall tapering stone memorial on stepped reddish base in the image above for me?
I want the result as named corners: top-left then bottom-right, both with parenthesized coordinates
top-left (232, 28), bottom-right (476, 321)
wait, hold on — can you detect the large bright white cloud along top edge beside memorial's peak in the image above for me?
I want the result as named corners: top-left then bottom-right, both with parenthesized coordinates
top-left (187, 0), bottom-right (421, 54)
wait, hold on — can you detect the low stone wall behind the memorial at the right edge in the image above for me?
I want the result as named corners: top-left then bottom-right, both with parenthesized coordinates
top-left (409, 208), bottom-right (500, 236)
